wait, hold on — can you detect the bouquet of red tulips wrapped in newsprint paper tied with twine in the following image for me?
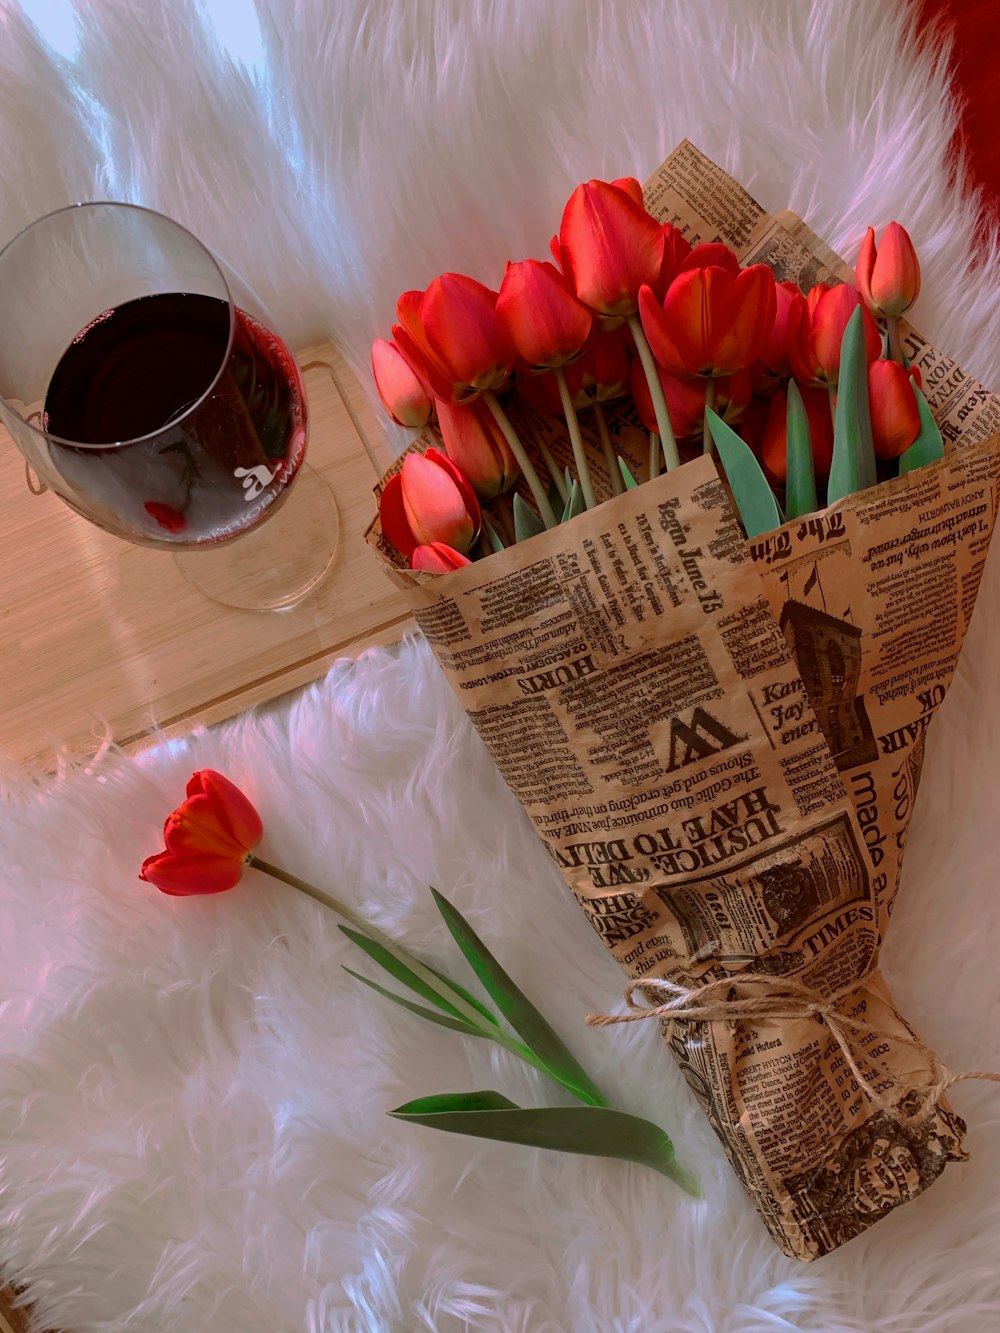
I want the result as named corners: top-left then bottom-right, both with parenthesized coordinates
top-left (369, 144), bottom-right (1000, 1258)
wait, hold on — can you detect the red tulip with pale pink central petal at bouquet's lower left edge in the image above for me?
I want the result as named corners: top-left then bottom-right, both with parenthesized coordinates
top-left (379, 449), bottom-right (483, 559)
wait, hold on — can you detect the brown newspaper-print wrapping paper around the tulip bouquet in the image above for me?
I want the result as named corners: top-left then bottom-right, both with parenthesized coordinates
top-left (369, 144), bottom-right (1000, 1260)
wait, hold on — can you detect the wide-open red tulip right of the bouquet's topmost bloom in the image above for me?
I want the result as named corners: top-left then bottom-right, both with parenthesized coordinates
top-left (639, 261), bottom-right (776, 377)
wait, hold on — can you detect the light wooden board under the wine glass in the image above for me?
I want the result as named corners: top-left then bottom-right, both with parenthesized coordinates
top-left (0, 343), bottom-right (409, 776)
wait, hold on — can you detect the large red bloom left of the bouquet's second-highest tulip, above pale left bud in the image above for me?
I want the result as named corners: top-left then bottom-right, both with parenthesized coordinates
top-left (396, 273), bottom-right (515, 403)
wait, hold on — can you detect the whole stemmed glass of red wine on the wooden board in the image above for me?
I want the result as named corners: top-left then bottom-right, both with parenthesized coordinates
top-left (0, 203), bottom-right (337, 609)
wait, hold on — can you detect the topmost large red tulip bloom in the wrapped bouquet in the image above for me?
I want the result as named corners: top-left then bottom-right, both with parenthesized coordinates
top-left (559, 180), bottom-right (664, 317)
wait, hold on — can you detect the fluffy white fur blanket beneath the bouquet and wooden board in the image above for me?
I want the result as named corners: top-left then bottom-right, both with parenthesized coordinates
top-left (0, 0), bottom-right (1000, 1333)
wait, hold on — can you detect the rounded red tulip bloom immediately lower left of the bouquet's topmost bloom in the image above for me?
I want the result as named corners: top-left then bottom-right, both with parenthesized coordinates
top-left (496, 259), bottom-right (593, 371)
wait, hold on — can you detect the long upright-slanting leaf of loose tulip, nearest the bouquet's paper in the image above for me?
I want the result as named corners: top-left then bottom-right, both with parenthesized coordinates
top-left (431, 889), bottom-right (608, 1106)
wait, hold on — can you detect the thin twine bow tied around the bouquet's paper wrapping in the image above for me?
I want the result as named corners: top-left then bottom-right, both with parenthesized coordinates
top-left (587, 974), bottom-right (1000, 1126)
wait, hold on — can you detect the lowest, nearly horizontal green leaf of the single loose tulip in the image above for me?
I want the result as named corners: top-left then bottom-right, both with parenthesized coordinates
top-left (389, 1092), bottom-right (699, 1198)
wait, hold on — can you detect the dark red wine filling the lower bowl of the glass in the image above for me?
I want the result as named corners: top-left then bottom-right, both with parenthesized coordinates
top-left (43, 292), bottom-right (307, 547)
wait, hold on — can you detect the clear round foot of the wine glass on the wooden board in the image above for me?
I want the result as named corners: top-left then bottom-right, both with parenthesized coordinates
top-left (173, 464), bottom-right (340, 611)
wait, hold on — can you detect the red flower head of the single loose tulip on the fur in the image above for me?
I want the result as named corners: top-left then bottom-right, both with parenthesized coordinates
top-left (139, 768), bottom-right (264, 896)
